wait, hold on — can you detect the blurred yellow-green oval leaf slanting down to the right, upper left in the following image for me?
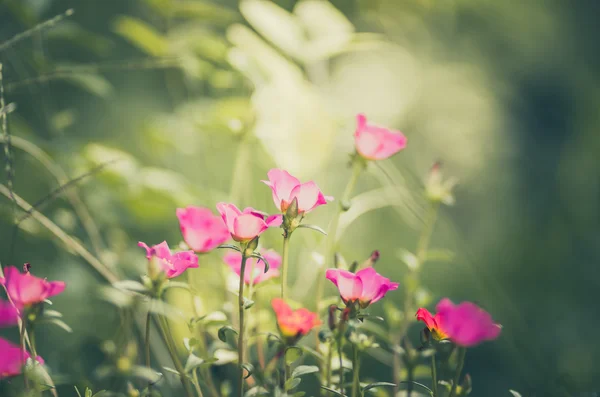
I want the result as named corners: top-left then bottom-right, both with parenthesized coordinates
top-left (113, 15), bottom-right (169, 57)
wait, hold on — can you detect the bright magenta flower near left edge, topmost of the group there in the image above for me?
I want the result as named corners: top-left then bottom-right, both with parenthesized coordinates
top-left (0, 266), bottom-right (66, 308)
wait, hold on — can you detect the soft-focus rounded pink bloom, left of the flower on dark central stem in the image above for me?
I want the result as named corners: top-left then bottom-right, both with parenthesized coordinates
top-left (176, 206), bottom-right (231, 252)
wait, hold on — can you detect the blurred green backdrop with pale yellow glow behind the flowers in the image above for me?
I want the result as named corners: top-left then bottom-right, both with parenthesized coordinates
top-left (0, 0), bottom-right (600, 397)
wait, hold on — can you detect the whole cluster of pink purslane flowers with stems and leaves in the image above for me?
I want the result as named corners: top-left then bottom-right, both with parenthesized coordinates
top-left (0, 115), bottom-right (508, 397)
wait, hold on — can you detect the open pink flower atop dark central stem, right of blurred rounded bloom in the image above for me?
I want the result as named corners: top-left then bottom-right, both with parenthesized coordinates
top-left (217, 203), bottom-right (282, 243)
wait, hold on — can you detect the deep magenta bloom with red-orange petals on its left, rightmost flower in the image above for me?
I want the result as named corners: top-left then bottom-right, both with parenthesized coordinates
top-left (417, 298), bottom-right (501, 347)
